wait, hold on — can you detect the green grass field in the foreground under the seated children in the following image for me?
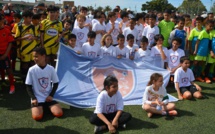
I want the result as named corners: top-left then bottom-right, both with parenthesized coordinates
top-left (0, 71), bottom-right (215, 134)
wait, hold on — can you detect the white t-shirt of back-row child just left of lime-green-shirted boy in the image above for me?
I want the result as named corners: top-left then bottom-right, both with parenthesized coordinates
top-left (142, 25), bottom-right (160, 48)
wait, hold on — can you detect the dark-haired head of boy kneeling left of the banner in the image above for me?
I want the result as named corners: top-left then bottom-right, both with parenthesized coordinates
top-left (32, 47), bottom-right (46, 66)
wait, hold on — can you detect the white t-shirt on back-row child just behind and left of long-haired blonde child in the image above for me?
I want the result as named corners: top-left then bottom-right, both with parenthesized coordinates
top-left (92, 22), bottom-right (106, 44)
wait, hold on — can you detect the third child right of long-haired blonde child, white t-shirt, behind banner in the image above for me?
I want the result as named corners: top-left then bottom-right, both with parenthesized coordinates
top-left (135, 36), bottom-right (151, 59)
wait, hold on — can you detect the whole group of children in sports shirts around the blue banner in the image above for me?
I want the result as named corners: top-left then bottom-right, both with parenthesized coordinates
top-left (0, 5), bottom-right (215, 133)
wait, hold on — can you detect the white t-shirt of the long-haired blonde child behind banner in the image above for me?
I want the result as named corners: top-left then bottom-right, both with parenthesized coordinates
top-left (100, 46), bottom-right (116, 57)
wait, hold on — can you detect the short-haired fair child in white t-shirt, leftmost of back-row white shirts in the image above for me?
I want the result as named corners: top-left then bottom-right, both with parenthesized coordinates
top-left (72, 15), bottom-right (89, 48)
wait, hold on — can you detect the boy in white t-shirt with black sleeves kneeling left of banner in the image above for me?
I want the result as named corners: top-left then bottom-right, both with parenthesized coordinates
top-left (25, 47), bottom-right (63, 120)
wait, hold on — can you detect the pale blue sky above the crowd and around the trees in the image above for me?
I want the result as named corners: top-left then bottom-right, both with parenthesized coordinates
top-left (5, 0), bottom-right (215, 12)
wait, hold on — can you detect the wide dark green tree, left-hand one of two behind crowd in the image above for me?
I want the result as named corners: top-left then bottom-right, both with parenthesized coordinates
top-left (141, 0), bottom-right (176, 12)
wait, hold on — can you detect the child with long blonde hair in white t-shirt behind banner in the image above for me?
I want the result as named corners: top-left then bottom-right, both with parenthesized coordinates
top-left (100, 34), bottom-right (116, 57)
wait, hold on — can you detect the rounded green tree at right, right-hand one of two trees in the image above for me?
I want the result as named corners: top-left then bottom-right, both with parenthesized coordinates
top-left (178, 0), bottom-right (207, 15)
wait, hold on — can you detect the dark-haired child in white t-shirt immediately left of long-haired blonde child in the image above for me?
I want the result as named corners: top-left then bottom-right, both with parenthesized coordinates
top-left (82, 31), bottom-right (101, 58)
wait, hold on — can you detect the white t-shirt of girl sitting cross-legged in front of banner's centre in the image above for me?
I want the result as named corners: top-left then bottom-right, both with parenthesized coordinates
top-left (94, 90), bottom-right (124, 114)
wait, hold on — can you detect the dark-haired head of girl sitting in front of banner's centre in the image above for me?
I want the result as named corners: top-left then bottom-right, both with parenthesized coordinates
top-left (103, 75), bottom-right (118, 96)
